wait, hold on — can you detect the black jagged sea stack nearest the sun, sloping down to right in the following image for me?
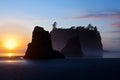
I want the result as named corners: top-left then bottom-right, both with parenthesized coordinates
top-left (24, 26), bottom-right (65, 59)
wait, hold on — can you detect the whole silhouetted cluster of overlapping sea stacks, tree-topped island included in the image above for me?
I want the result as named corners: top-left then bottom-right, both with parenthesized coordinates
top-left (24, 22), bottom-right (104, 59)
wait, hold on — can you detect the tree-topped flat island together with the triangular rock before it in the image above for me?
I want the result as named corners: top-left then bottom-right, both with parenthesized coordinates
top-left (50, 22), bottom-right (103, 57)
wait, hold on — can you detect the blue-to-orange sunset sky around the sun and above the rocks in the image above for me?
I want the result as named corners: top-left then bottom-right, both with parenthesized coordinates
top-left (0, 0), bottom-right (120, 55)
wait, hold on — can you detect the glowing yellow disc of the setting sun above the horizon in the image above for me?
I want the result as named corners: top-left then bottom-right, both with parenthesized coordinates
top-left (3, 39), bottom-right (18, 50)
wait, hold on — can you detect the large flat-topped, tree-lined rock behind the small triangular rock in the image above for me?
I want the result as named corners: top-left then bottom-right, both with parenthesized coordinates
top-left (50, 24), bottom-right (103, 57)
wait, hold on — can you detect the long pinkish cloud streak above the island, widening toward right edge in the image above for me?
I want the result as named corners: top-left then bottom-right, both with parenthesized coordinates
top-left (62, 9), bottom-right (120, 20)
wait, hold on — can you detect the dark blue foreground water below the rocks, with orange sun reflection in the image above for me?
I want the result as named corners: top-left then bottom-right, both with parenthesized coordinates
top-left (0, 57), bottom-right (120, 80)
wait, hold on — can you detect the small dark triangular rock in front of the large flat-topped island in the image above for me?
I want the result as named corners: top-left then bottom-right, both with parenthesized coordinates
top-left (61, 36), bottom-right (83, 57)
